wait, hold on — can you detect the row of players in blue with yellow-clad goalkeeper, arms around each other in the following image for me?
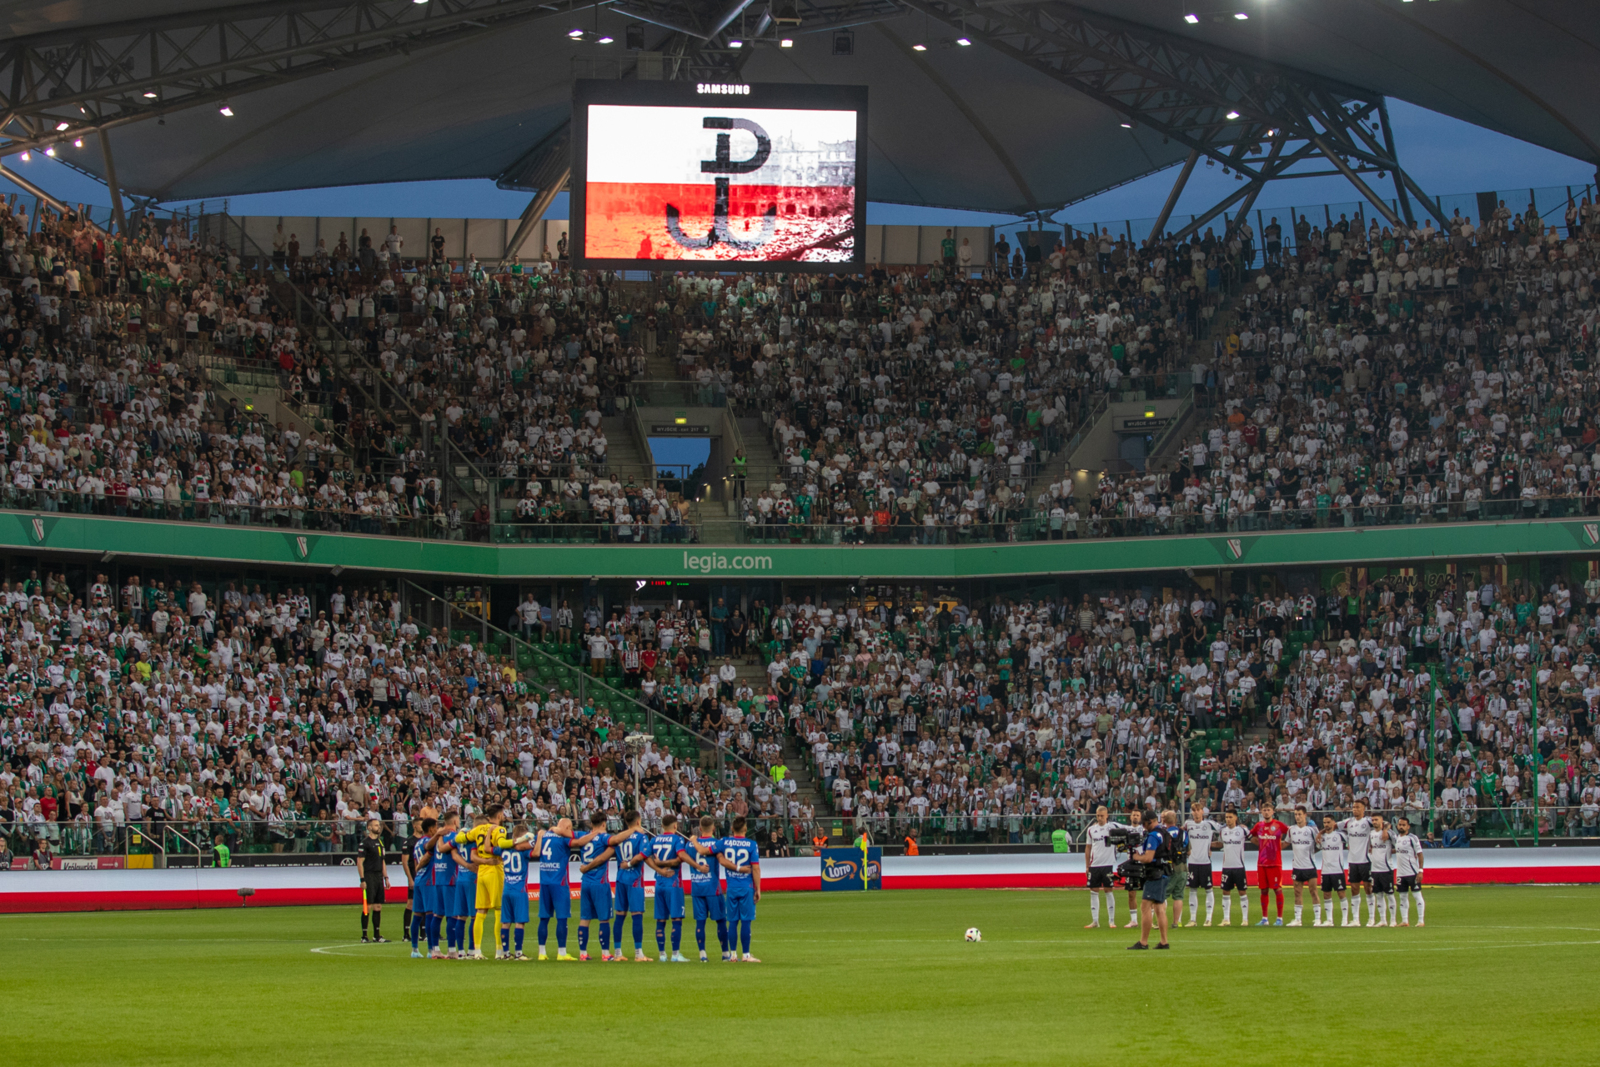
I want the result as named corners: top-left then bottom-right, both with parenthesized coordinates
top-left (392, 805), bottom-right (762, 963)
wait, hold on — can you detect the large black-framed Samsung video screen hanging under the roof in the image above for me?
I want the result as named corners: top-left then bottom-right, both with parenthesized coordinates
top-left (571, 82), bottom-right (867, 270)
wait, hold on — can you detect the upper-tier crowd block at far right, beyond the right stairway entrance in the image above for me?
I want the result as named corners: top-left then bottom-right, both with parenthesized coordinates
top-left (1051, 200), bottom-right (1600, 536)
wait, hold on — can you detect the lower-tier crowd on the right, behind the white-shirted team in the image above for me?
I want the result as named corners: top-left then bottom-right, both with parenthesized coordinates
top-left (752, 566), bottom-right (1600, 841)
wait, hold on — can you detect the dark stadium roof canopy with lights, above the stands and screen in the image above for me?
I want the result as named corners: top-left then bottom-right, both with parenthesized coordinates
top-left (9, 0), bottom-right (1600, 213)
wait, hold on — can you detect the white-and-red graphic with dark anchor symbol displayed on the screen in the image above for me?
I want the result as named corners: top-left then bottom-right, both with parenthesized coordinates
top-left (584, 104), bottom-right (856, 262)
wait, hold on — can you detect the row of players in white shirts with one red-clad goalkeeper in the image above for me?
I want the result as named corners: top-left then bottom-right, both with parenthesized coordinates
top-left (1085, 800), bottom-right (1426, 929)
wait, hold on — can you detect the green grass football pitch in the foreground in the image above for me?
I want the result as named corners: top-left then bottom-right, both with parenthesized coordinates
top-left (0, 888), bottom-right (1600, 1067)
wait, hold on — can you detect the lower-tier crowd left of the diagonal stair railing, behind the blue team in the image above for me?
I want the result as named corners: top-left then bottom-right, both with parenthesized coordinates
top-left (0, 574), bottom-right (810, 854)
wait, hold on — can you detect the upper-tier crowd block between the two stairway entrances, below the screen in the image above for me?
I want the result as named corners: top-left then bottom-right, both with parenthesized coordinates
top-left (707, 234), bottom-right (1242, 544)
